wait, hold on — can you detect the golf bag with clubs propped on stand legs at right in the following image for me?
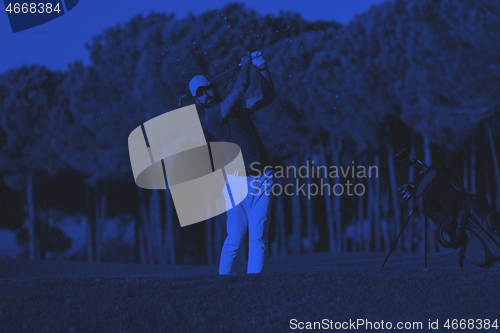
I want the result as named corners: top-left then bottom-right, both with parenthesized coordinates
top-left (390, 148), bottom-right (500, 267)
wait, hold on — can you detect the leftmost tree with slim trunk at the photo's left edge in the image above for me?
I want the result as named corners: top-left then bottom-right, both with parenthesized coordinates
top-left (0, 66), bottom-right (64, 260)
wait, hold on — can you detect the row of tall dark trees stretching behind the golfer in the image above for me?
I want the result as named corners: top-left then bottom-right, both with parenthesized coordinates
top-left (0, 0), bottom-right (500, 264)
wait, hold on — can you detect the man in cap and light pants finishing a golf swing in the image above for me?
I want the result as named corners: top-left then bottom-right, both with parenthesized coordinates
top-left (189, 51), bottom-right (275, 274)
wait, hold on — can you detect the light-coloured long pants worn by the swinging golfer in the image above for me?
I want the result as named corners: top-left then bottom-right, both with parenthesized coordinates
top-left (219, 171), bottom-right (273, 274)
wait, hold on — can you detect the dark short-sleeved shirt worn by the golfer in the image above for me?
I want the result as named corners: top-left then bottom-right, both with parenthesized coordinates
top-left (197, 104), bottom-right (270, 172)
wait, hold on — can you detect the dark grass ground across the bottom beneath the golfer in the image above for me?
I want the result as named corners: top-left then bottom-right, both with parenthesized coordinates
top-left (0, 252), bottom-right (500, 332)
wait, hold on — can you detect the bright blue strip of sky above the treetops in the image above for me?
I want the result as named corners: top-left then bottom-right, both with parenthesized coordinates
top-left (0, 0), bottom-right (387, 73)
